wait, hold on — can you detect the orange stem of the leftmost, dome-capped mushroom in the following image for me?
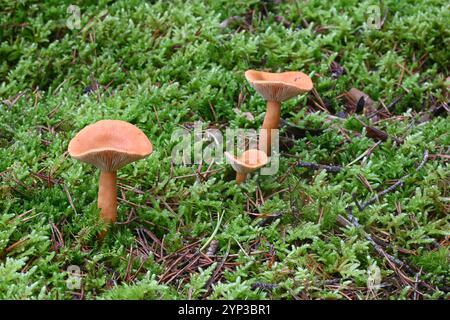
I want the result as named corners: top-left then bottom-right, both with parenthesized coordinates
top-left (98, 171), bottom-right (117, 223)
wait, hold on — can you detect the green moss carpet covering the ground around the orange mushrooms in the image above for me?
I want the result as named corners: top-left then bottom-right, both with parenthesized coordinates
top-left (0, 0), bottom-right (450, 299)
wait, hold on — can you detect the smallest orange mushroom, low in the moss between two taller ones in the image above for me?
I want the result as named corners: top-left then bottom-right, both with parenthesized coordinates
top-left (225, 149), bottom-right (269, 184)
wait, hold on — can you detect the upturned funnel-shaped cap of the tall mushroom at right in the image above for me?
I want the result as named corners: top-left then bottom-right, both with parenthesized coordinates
top-left (245, 70), bottom-right (313, 102)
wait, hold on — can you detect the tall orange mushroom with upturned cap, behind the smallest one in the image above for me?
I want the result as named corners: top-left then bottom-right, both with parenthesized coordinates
top-left (245, 70), bottom-right (313, 156)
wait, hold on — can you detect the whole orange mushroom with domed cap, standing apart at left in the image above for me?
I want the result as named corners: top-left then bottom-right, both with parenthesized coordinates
top-left (68, 120), bottom-right (153, 230)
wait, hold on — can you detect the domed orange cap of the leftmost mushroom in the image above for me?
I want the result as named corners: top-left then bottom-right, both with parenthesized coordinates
top-left (69, 120), bottom-right (153, 171)
